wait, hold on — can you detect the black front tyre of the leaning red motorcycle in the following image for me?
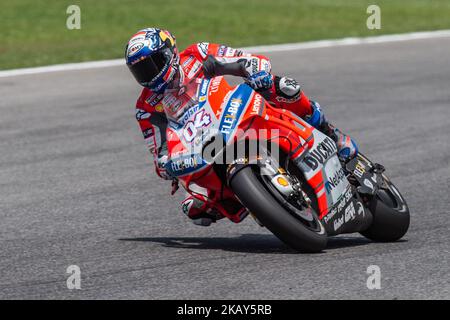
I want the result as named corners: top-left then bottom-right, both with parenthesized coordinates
top-left (230, 166), bottom-right (327, 252)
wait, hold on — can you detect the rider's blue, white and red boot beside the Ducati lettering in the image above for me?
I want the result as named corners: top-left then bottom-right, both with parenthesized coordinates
top-left (305, 101), bottom-right (358, 162)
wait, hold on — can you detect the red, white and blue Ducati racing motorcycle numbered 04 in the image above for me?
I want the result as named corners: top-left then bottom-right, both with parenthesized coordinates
top-left (166, 77), bottom-right (410, 252)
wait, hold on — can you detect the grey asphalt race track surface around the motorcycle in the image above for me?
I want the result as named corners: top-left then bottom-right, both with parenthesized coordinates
top-left (0, 38), bottom-right (450, 299)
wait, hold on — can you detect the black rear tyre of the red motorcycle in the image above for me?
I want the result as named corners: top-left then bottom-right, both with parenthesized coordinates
top-left (361, 175), bottom-right (410, 242)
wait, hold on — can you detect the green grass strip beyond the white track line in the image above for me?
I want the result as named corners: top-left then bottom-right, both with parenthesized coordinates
top-left (0, 0), bottom-right (450, 69)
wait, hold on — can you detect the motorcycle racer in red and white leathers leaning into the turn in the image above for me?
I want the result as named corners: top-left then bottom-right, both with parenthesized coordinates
top-left (125, 28), bottom-right (358, 226)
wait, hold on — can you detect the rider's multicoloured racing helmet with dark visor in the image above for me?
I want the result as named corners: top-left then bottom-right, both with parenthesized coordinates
top-left (125, 28), bottom-right (180, 93)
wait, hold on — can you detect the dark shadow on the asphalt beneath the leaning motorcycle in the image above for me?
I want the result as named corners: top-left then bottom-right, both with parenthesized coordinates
top-left (119, 234), bottom-right (371, 254)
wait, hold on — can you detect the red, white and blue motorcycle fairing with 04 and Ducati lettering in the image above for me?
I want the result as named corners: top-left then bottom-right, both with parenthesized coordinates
top-left (167, 77), bottom-right (366, 234)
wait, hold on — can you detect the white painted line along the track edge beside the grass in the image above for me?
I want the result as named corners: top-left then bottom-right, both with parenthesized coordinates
top-left (0, 30), bottom-right (450, 78)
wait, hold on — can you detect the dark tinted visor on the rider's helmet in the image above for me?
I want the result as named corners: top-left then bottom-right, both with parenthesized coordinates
top-left (128, 48), bottom-right (173, 87)
